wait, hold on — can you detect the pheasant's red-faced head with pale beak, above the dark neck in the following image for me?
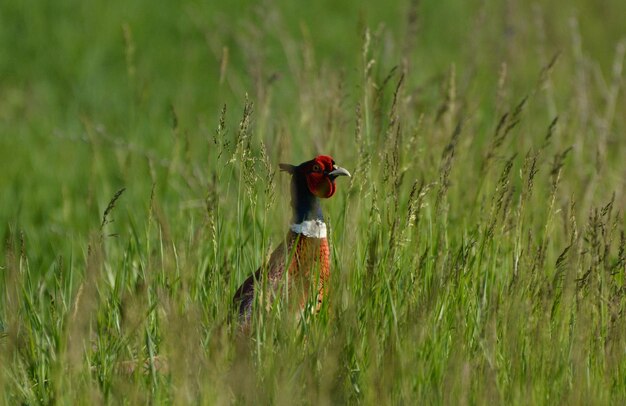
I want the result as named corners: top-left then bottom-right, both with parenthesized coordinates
top-left (280, 155), bottom-right (350, 199)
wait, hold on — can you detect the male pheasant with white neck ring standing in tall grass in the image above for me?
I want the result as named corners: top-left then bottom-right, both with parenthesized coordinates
top-left (233, 155), bottom-right (351, 331)
